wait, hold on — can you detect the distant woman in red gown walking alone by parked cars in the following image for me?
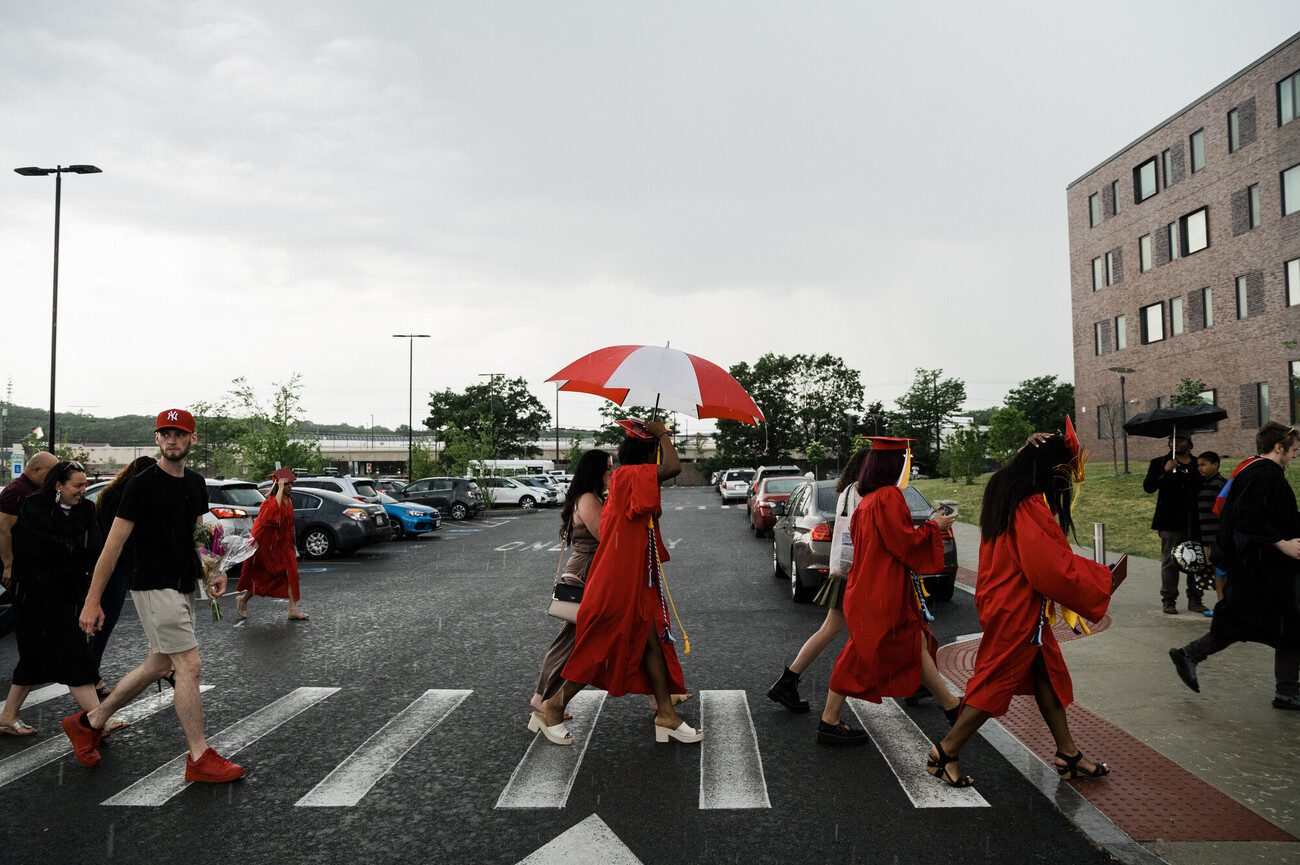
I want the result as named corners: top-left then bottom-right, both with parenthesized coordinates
top-left (235, 468), bottom-right (311, 620)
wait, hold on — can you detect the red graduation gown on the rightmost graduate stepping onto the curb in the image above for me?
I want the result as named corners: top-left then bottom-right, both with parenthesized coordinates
top-left (966, 496), bottom-right (1110, 715)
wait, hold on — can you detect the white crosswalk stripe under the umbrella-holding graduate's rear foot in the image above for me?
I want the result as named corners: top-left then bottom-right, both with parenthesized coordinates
top-left (497, 691), bottom-right (606, 811)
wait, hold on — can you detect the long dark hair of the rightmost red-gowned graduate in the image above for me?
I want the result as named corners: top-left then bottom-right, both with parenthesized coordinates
top-left (979, 436), bottom-right (1074, 541)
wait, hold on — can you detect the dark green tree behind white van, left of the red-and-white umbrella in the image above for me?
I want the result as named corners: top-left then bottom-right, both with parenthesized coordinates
top-left (424, 376), bottom-right (551, 459)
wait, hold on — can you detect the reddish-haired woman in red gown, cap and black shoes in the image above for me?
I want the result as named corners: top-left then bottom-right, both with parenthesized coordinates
top-left (816, 436), bottom-right (959, 745)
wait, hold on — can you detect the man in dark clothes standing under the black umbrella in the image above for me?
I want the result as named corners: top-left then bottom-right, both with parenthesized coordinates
top-left (1141, 436), bottom-right (1206, 615)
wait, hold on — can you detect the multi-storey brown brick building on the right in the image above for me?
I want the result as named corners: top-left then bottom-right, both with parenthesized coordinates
top-left (1066, 34), bottom-right (1300, 459)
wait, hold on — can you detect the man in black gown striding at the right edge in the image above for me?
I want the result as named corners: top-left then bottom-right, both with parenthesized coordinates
top-left (1169, 420), bottom-right (1300, 710)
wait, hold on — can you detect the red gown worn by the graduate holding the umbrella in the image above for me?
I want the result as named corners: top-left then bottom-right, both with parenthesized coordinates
top-left (563, 464), bottom-right (686, 697)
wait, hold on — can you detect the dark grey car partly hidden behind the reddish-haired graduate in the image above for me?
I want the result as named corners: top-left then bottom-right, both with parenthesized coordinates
top-left (772, 480), bottom-right (957, 604)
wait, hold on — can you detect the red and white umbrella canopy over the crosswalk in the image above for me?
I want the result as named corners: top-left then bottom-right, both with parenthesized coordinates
top-left (547, 346), bottom-right (764, 425)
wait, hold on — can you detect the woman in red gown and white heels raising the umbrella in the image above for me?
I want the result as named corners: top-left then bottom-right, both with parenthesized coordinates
top-left (528, 421), bottom-right (703, 745)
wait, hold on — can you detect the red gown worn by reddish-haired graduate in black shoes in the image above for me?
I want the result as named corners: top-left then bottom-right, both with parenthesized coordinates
top-left (831, 486), bottom-right (944, 702)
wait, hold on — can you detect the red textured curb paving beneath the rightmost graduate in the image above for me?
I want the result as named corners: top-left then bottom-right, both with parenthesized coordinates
top-left (939, 568), bottom-right (1300, 842)
